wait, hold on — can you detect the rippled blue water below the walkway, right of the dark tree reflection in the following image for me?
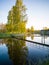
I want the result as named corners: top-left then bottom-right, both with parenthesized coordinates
top-left (26, 43), bottom-right (49, 65)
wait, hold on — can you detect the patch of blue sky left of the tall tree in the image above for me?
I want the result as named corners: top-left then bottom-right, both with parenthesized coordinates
top-left (0, 0), bottom-right (15, 23)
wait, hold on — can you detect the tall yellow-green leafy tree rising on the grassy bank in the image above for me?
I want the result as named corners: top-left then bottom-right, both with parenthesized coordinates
top-left (8, 0), bottom-right (27, 33)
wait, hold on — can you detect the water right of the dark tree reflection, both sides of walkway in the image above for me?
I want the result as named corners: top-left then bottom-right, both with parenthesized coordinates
top-left (26, 35), bottom-right (49, 65)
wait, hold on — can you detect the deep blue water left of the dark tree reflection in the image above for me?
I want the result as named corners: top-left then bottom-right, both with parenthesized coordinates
top-left (0, 39), bottom-right (12, 65)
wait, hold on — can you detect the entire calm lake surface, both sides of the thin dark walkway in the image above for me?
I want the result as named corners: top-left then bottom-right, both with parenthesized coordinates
top-left (0, 35), bottom-right (49, 65)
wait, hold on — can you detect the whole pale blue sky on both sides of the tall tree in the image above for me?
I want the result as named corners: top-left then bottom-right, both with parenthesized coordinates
top-left (0, 0), bottom-right (49, 29)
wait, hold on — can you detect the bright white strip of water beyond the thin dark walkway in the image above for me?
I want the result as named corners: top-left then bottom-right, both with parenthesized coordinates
top-left (26, 34), bottom-right (49, 44)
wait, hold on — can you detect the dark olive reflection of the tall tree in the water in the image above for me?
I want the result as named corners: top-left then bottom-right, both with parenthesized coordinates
top-left (7, 39), bottom-right (28, 65)
